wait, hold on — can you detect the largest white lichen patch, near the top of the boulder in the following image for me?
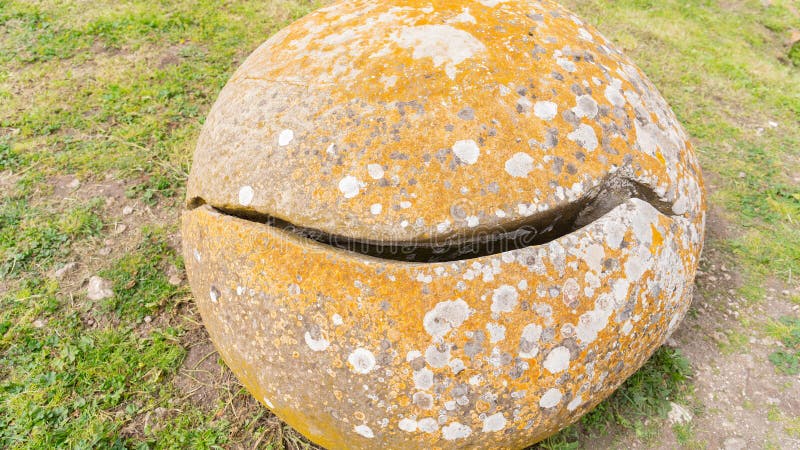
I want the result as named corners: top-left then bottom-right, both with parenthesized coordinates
top-left (392, 25), bottom-right (486, 80)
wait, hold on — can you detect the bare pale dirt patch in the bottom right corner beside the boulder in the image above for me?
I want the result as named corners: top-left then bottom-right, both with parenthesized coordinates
top-left (663, 284), bottom-right (800, 448)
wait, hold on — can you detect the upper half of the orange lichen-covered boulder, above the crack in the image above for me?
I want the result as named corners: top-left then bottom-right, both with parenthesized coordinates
top-left (188, 0), bottom-right (703, 241)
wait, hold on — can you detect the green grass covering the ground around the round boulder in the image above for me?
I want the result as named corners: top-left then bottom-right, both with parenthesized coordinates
top-left (0, 0), bottom-right (800, 449)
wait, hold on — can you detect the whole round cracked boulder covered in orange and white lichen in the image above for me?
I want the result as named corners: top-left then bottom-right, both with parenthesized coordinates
top-left (182, 0), bottom-right (705, 449)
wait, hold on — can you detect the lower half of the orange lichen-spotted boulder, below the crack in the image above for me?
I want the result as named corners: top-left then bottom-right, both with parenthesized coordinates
top-left (182, 199), bottom-right (702, 449)
